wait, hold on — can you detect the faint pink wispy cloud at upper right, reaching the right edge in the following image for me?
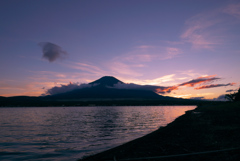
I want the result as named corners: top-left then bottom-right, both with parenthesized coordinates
top-left (181, 3), bottom-right (240, 49)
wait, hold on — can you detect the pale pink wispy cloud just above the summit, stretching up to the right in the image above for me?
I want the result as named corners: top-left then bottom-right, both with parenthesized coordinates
top-left (105, 45), bottom-right (182, 78)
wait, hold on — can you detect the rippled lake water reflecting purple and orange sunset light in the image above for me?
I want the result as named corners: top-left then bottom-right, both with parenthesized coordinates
top-left (0, 106), bottom-right (195, 160)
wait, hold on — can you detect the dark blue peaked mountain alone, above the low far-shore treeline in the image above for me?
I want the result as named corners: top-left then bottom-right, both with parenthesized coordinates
top-left (46, 76), bottom-right (163, 99)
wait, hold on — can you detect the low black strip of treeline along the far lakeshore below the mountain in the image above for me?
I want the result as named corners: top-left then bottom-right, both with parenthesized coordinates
top-left (0, 97), bottom-right (223, 107)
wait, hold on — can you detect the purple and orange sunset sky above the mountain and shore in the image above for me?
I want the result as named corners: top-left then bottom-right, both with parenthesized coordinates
top-left (0, 0), bottom-right (240, 99)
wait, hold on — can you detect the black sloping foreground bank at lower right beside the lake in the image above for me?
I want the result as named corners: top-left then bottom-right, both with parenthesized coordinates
top-left (82, 102), bottom-right (240, 161)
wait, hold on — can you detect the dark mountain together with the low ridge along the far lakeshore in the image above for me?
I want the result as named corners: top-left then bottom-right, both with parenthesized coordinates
top-left (0, 76), bottom-right (209, 107)
